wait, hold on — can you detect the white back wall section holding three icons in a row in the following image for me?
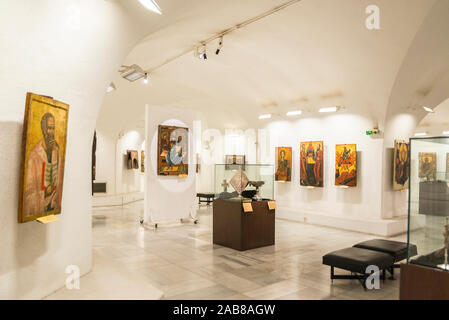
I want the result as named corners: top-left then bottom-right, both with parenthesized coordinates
top-left (259, 113), bottom-right (382, 220)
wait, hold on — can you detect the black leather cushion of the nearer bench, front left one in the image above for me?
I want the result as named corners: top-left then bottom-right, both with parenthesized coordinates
top-left (323, 247), bottom-right (394, 274)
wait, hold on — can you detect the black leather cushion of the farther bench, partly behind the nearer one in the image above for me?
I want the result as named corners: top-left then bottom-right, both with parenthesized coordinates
top-left (354, 239), bottom-right (418, 262)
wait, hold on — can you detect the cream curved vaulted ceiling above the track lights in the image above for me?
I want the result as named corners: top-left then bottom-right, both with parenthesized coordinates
top-left (97, 0), bottom-right (449, 135)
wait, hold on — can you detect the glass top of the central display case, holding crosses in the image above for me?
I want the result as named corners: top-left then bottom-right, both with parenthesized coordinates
top-left (215, 164), bottom-right (274, 200)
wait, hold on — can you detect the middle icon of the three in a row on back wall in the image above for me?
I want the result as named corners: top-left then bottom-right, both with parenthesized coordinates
top-left (299, 141), bottom-right (324, 187)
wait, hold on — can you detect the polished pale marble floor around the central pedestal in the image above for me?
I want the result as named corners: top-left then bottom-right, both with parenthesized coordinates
top-left (65, 202), bottom-right (405, 300)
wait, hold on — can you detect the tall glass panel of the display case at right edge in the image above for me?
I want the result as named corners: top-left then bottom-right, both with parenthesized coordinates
top-left (407, 137), bottom-right (449, 271)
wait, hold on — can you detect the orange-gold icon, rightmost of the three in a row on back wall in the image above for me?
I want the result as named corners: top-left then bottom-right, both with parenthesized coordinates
top-left (335, 144), bottom-right (357, 187)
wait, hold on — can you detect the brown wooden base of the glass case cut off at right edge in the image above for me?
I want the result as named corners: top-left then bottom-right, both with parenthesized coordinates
top-left (400, 264), bottom-right (449, 300)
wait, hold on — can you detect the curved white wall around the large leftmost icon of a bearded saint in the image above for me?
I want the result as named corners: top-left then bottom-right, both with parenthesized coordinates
top-left (0, 0), bottom-right (144, 299)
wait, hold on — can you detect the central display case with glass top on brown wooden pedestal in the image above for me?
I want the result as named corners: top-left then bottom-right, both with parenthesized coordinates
top-left (212, 164), bottom-right (276, 251)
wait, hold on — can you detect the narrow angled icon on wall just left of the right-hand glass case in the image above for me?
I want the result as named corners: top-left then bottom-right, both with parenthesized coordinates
top-left (393, 140), bottom-right (410, 190)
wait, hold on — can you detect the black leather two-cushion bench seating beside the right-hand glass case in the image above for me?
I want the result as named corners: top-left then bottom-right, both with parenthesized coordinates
top-left (323, 239), bottom-right (418, 287)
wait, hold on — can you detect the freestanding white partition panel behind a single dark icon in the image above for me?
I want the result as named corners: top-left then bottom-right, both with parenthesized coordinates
top-left (143, 105), bottom-right (198, 227)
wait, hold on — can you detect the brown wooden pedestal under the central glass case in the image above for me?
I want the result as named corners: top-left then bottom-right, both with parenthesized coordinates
top-left (213, 199), bottom-right (275, 251)
